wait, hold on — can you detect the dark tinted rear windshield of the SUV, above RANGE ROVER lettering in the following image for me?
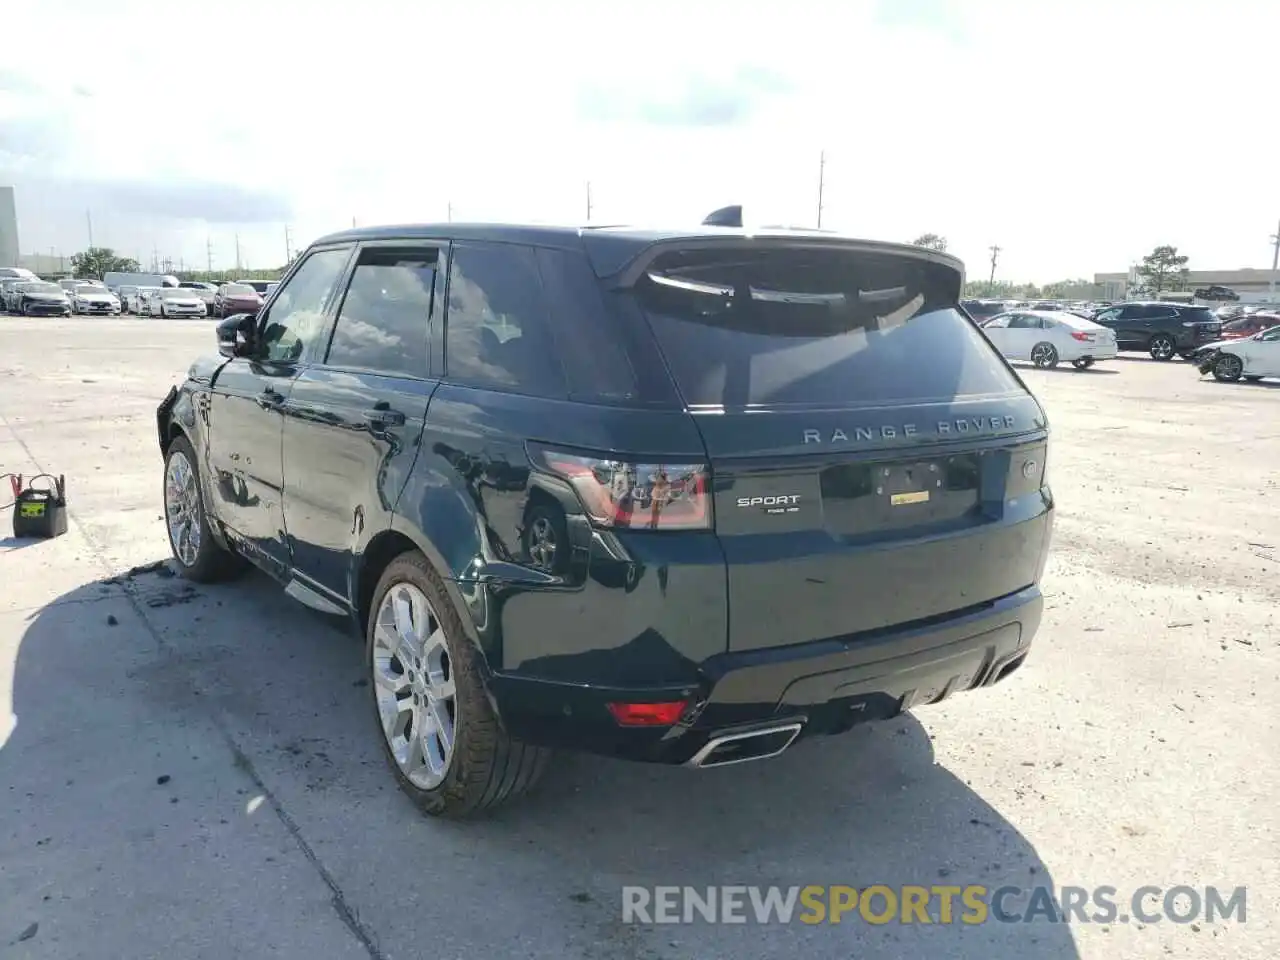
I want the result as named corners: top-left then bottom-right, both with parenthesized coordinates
top-left (636, 248), bottom-right (1020, 407)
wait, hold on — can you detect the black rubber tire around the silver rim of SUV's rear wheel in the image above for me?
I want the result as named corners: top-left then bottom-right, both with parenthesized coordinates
top-left (365, 550), bottom-right (552, 819)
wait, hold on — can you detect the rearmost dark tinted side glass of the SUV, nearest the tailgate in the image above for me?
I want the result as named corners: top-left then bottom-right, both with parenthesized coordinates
top-left (536, 248), bottom-right (639, 401)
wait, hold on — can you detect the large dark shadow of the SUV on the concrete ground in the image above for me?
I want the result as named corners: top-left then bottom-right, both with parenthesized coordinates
top-left (0, 563), bottom-right (1079, 960)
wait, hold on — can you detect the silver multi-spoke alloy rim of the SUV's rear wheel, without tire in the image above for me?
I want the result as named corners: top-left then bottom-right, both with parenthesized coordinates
top-left (372, 581), bottom-right (458, 790)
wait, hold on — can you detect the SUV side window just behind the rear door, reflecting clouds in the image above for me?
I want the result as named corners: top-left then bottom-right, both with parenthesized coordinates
top-left (444, 243), bottom-right (566, 397)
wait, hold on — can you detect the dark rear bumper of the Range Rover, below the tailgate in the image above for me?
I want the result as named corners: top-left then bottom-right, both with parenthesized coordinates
top-left (490, 586), bottom-right (1043, 764)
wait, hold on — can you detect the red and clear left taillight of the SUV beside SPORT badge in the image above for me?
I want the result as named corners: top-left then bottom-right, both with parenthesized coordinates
top-left (530, 447), bottom-right (712, 530)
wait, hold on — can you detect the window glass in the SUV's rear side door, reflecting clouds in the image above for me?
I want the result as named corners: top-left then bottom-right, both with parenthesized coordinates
top-left (325, 247), bottom-right (439, 376)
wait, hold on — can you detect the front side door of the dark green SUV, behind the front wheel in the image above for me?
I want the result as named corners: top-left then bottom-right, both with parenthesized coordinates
top-left (207, 246), bottom-right (351, 575)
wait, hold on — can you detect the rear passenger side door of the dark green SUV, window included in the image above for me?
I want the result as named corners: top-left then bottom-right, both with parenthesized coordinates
top-left (284, 243), bottom-right (444, 603)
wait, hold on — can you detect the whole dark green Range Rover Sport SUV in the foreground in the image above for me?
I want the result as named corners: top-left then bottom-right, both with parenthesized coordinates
top-left (157, 216), bottom-right (1053, 817)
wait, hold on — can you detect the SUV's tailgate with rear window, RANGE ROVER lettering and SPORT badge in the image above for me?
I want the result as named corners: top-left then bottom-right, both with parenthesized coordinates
top-left (634, 241), bottom-right (1048, 650)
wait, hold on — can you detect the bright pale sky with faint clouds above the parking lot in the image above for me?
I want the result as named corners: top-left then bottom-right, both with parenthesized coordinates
top-left (0, 0), bottom-right (1280, 283)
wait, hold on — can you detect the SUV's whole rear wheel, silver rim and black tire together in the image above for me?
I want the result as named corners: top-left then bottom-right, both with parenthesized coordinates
top-left (365, 550), bottom-right (550, 819)
